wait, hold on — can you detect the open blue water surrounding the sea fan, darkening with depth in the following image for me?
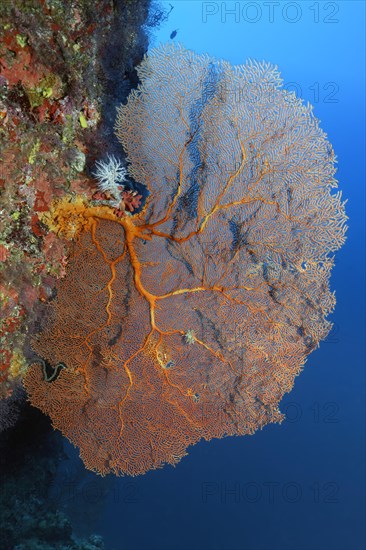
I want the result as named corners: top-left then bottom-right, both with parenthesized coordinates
top-left (58, 0), bottom-right (366, 550)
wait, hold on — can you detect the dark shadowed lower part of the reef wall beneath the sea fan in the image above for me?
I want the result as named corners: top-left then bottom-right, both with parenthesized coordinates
top-left (0, 396), bottom-right (104, 550)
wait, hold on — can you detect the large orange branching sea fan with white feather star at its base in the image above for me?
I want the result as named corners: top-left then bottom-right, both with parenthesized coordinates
top-left (20, 45), bottom-right (346, 475)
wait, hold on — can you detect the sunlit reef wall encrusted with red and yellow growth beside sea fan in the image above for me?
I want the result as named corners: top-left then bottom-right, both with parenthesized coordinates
top-left (0, 0), bottom-right (165, 404)
